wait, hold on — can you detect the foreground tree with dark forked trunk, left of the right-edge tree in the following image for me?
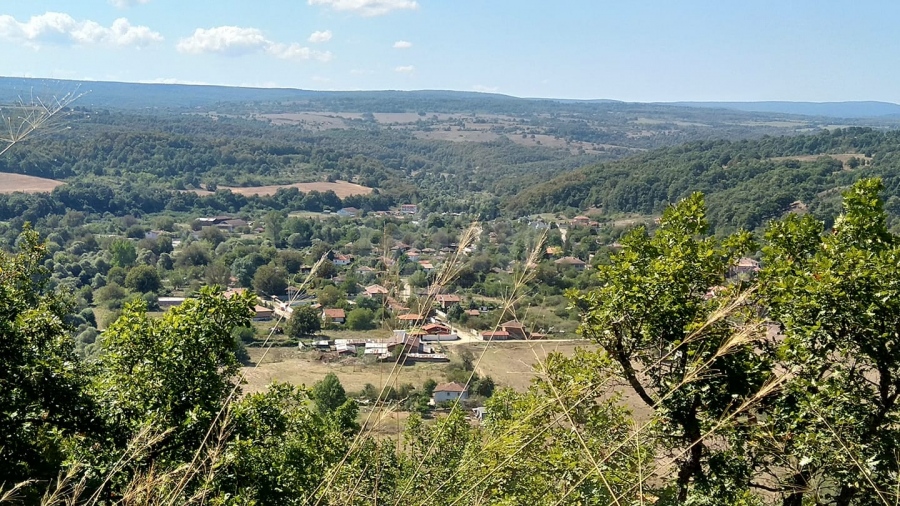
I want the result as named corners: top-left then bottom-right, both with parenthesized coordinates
top-left (569, 194), bottom-right (770, 503)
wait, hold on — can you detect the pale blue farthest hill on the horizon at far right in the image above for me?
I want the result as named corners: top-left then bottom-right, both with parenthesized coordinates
top-left (665, 102), bottom-right (900, 118)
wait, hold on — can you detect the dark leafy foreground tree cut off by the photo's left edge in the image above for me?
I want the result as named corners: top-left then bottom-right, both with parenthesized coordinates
top-left (0, 228), bottom-right (93, 485)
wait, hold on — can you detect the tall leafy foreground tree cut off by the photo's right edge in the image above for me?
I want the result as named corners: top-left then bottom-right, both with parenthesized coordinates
top-left (760, 179), bottom-right (900, 506)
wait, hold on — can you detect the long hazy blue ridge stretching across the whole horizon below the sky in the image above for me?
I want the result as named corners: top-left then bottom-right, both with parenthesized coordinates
top-left (0, 77), bottom-right (900, 121)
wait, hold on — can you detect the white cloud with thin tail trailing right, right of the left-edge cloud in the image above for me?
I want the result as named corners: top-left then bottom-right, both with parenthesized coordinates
top-left (176, 26), bottom-right (331, 61)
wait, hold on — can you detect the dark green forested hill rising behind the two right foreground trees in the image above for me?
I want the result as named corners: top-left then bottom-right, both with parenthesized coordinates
top-left (508, 128), bottom-right (900, 230)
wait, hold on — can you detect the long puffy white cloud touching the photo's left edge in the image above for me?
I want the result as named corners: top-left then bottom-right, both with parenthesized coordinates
top-left (0, 12), bottom-right (163, 47)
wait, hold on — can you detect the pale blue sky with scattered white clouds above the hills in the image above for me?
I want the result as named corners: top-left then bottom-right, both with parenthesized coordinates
top-left (0, 0), bottom-right (900, 103)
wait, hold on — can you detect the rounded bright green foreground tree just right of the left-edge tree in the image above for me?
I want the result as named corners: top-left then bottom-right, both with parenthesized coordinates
top-left (77, 288), bottom-right (252, 479)
